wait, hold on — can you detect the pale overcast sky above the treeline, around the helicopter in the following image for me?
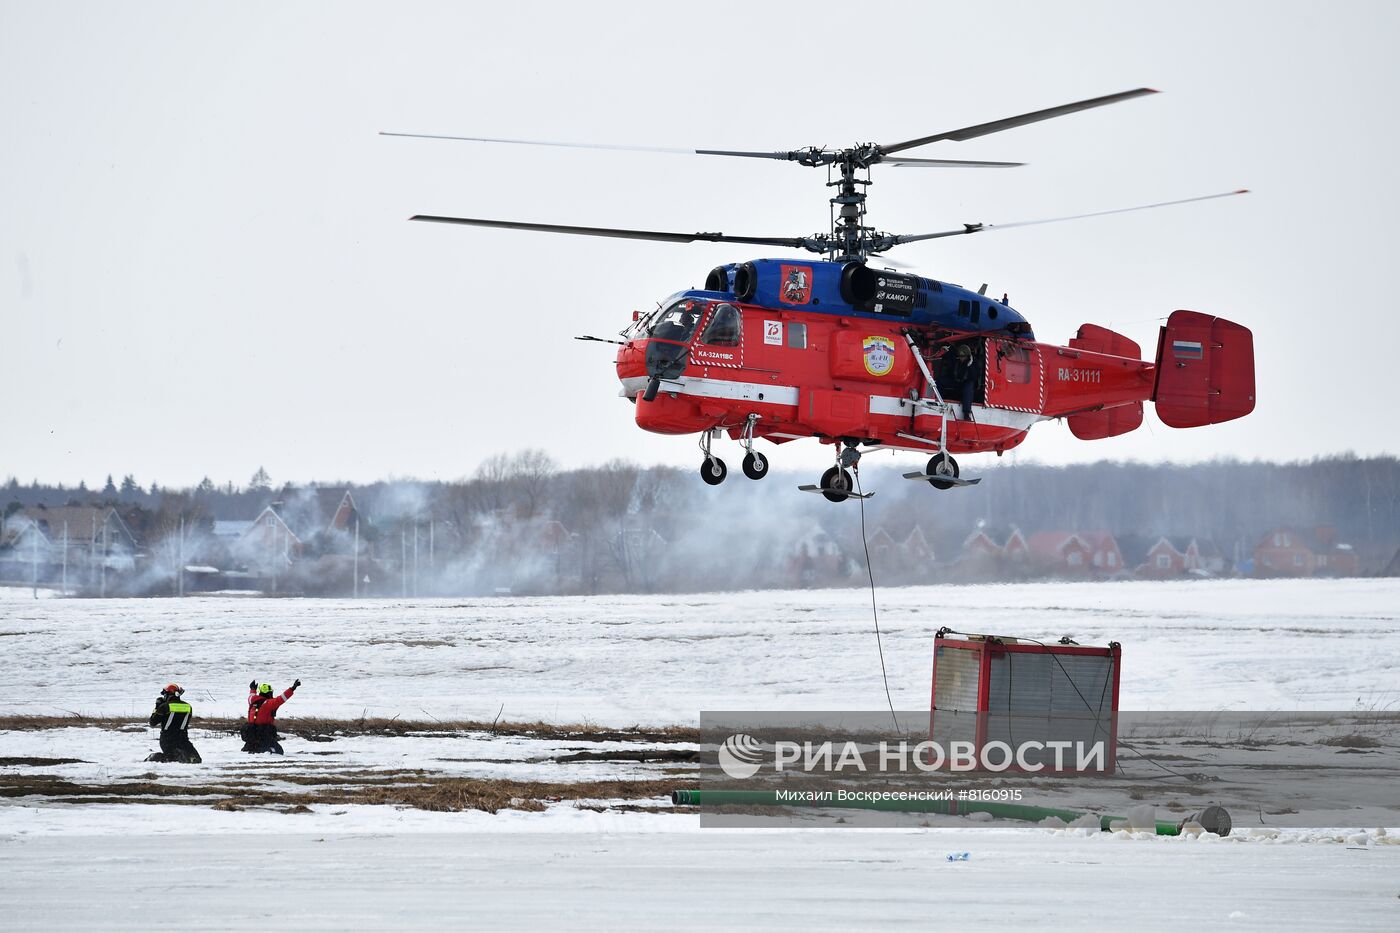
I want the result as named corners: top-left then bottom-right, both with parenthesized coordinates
top-left (0, 0), bottom-right (1400, 485)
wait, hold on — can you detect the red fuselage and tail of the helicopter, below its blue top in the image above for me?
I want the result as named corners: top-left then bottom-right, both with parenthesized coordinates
top-left (616, 257), bottom-right (1254, 473)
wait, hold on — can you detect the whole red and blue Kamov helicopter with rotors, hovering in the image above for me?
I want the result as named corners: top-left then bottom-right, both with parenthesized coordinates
top-left (382, 87), bottom-right (1254, 502)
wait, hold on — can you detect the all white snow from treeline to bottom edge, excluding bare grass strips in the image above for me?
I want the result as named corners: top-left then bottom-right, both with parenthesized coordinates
top-left (0, 580), bottom-right (1400, 930)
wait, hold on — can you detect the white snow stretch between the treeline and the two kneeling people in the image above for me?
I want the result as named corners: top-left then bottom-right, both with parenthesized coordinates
top-left (0, 580), bottom-right (1400, 726)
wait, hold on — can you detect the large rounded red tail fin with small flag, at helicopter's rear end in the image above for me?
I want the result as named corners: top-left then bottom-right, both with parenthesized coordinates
top-left (1152, 311), bottom-right (1254, 427)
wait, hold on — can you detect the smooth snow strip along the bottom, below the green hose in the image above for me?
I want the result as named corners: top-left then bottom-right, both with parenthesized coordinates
top-left (0, 817), bottom-right (1400, 933)
